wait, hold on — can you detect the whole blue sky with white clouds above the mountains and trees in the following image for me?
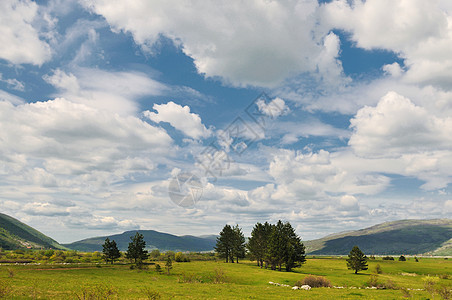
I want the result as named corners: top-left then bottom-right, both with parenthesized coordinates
top-left (0, 0), bottom-right (452, 243)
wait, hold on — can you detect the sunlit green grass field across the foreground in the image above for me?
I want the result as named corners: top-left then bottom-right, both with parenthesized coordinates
top-left (0, 258), bottom-right (452, 299)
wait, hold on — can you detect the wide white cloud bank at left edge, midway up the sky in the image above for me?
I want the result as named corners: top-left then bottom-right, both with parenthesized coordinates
top-left (0, 99), bottom-right (172, 188)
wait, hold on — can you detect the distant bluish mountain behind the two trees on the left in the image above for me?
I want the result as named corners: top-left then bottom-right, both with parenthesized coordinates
top-left (64, 230), bottom-right (216, 252)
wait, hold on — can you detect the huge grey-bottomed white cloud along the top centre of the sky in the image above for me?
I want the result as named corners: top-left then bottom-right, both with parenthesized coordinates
top-left (82, 0), bottom-right (340, 86)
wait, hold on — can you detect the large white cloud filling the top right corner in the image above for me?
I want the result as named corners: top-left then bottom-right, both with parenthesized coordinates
top-left (322, 0), bottom-right (452, 90)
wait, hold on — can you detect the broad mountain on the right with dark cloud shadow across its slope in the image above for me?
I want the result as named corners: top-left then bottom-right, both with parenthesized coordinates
top-left (304, 219), bottom-right (452, 255)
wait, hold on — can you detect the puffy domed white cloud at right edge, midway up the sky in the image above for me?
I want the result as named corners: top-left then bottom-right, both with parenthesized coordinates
top-left (349, 92), bottom-right (452, 157)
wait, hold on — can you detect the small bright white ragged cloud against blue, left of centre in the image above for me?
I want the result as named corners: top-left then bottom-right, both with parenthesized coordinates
top-left (143, 101), bottom-right (212, 139)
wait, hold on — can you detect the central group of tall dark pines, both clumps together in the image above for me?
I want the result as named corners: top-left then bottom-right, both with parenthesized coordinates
top-left (215, 220), bottom-right (306, 271)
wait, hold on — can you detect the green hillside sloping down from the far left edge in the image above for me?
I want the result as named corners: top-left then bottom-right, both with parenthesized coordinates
top-left (0, 213), bottom-right (66, 250)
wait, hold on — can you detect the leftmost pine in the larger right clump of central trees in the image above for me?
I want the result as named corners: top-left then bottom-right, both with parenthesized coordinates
top-left (246, 222), bottom-right (272, 268)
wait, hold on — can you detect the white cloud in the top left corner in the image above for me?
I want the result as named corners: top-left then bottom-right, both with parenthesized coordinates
top-left (0, 0), bottom-right (51, 65)
